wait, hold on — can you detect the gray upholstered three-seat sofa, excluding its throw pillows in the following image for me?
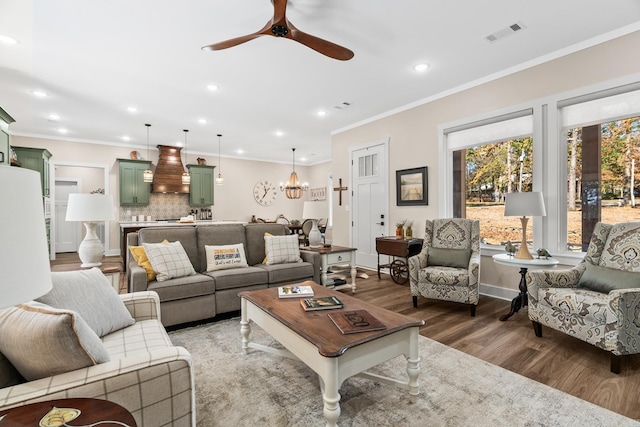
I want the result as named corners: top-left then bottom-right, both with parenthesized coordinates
top-left (126, 224), bottom-right (321, 327)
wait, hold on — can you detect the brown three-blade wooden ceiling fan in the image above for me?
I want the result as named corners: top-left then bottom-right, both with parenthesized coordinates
top-left (202, 0), bottom-right (353, 61)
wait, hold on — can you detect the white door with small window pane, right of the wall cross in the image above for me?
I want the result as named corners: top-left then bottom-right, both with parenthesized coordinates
top-left (351, 140), bottom-right (389, 269)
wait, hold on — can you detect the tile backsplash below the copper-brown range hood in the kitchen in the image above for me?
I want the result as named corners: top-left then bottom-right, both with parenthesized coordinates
top-left (119, 193), bottom-right (213, 221)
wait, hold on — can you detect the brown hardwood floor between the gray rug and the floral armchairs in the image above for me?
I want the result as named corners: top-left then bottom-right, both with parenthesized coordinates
top-left (47, 254), bottom-right (640, 420)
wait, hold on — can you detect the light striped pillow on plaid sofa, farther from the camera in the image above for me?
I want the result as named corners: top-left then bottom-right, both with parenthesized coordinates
top-left (37, 267), bottom-right (135, 337)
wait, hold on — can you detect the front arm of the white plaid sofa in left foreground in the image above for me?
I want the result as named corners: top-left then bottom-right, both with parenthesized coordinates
top-left (0, 347), bottom-right (195, 426)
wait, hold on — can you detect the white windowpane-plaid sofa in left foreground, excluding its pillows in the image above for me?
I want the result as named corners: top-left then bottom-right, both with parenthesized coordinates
top-left (0, 292), bottom-right (196, 427)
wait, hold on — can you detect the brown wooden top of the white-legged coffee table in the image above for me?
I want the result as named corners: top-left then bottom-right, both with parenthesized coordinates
top-left (238, 281), bottom-right (424, 357)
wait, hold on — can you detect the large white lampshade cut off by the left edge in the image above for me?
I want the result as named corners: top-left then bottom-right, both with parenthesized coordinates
top-left (0, 166), bottom-right (51, 308)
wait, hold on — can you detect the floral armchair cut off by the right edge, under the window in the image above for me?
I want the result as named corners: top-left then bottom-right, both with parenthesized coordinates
top-left (526, 222), bottom-right (640, 374)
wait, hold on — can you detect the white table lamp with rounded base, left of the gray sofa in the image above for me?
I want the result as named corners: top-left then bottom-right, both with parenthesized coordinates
top-left (66, 193), bottom-right (114, 267)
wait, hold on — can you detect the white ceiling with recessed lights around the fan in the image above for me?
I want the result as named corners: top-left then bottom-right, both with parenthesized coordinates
top-left (0, 0), bottom-right (640, 164)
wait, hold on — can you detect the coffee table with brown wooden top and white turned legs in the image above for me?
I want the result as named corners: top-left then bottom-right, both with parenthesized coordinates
top-left (238, 281), bottom-right (424, 427)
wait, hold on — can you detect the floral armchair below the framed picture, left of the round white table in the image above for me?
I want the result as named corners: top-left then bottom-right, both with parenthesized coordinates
top-left (408, 218), bottom-right (480, 316)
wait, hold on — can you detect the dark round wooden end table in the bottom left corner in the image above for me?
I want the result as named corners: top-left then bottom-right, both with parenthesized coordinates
top-left (0, 398), bottom-right (137, 427)
